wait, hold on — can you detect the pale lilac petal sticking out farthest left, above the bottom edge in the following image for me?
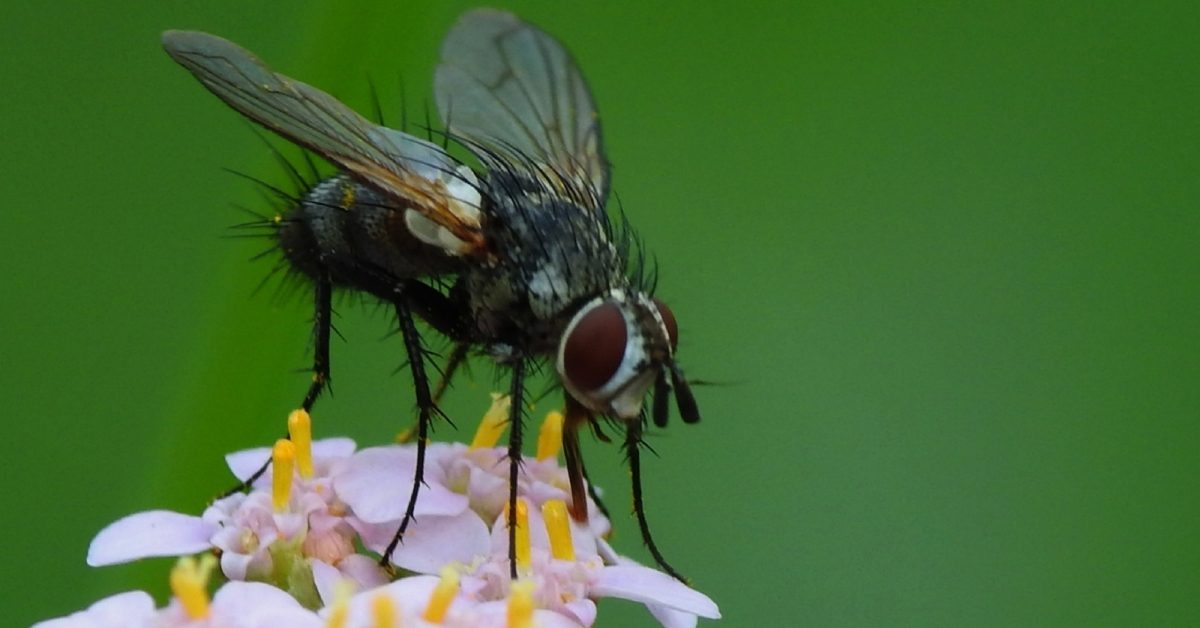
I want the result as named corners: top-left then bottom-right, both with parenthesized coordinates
top-left (88, 510), bottom-right (217, 567)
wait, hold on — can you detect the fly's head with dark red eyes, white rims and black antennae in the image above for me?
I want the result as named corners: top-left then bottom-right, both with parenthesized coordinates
top-left (556, 289), bottom-right (700, 425)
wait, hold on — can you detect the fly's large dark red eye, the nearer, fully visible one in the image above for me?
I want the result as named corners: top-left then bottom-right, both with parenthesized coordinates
top-left (563, 303), bottom-right (629, 390)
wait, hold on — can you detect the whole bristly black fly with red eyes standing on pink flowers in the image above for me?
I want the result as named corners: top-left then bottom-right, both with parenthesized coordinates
top-left (163, 10), bottom-right (700, 579)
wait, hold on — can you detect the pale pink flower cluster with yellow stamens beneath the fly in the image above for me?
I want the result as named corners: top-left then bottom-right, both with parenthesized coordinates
top-left (37, 395), bottom-right (720, 628)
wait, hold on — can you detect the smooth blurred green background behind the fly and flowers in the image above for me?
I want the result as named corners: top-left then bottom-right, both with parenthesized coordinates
top-left (0, 0), bottom-right (1200, 626)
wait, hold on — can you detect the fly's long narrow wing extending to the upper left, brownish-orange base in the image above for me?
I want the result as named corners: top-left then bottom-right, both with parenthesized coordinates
top-left (162, 31), bottom-right (485, 255)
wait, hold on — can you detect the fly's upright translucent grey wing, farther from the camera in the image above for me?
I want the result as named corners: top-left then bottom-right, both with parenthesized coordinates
top-left (434, 8), bottom-right (608, 210)
